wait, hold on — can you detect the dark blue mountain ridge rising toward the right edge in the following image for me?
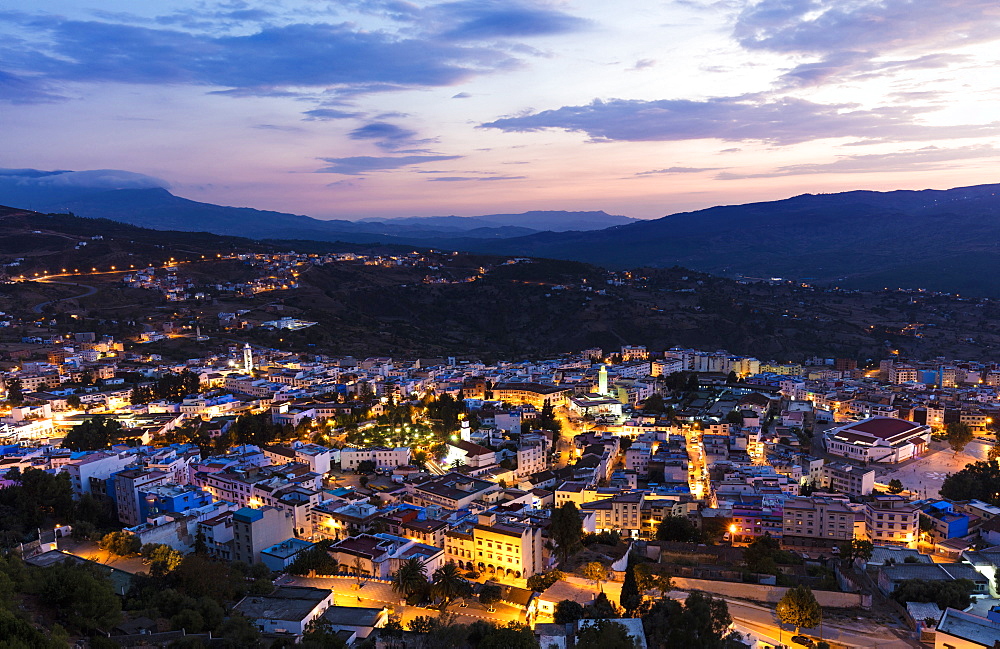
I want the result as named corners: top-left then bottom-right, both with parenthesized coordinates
top-left (462, 185), bottom-right (1000, 295)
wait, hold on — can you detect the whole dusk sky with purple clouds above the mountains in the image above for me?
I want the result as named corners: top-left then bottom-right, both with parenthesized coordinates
top-left (0, 0), bottom-right (1000, 219)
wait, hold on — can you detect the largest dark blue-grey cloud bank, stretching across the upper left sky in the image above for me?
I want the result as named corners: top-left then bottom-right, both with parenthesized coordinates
top-left (0, 13), bottom-right (517, 96)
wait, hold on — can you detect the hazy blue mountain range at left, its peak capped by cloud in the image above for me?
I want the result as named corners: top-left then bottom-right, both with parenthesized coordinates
top-left (0, 169), bottom-right (634, 247)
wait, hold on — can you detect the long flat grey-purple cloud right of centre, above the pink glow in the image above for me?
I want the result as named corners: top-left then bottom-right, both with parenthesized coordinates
top-left (480, 96), bottom-right (1000, 145)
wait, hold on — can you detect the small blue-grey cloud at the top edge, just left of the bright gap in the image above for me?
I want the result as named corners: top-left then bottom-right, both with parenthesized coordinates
top-left (427, 0), bottom-right (589, 41)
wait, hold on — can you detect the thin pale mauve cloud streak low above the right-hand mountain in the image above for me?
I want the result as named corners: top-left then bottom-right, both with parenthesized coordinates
top-left (716, 144), bottom-right (1000, 180)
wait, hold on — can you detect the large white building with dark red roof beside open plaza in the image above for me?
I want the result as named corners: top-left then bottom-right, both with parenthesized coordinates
top-left (826, 417), bottom-right (931, 464)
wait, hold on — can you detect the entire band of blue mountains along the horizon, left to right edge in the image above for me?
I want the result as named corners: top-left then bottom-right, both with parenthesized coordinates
top-left (0, 170), bottom-right (1000, 296)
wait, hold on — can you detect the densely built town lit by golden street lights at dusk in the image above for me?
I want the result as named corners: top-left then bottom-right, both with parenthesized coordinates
top-left (0, 332), bottom-right (1000, 647)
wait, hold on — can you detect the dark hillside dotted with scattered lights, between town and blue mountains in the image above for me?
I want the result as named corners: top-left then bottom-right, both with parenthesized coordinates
top-left (0, 208), bottom-right (1000, 360)
